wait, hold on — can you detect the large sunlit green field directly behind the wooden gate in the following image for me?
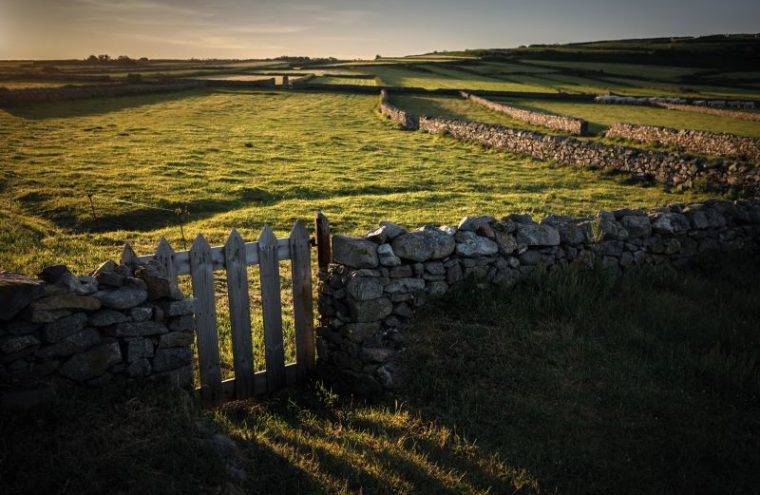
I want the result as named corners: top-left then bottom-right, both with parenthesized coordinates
top-left (0, 91), bottom-right (712, 278)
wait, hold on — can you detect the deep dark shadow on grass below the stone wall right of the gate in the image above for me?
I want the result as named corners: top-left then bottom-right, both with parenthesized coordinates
top-left (400, 260), bottom-right (760, 493)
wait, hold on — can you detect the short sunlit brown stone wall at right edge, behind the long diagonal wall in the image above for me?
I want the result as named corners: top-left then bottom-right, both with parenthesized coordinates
top-left (605, 123), bottom-right (760, 163)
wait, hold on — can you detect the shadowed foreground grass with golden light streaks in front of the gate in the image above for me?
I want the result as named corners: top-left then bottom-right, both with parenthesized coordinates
top-left (0, 259), bottom-right (760, 493)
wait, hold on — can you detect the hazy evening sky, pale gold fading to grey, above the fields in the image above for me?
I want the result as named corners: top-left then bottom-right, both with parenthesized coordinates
top-left (0, 0), bottom-right (760, 60)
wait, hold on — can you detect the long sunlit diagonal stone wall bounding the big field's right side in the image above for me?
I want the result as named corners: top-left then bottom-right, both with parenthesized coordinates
top-left (419, 116), bottom-right (760, 195)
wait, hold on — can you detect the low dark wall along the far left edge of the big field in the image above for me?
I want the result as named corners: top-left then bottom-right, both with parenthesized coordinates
top-left (0, 80), bottom-right (205, 106)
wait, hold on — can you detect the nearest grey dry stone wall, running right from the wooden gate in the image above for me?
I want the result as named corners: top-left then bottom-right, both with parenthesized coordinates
top-left (317, 201), bottom-right (760, 395)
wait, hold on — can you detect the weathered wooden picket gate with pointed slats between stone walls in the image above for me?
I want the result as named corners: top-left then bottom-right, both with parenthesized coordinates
top-left (121, 221), bottom-right (315, 404)
